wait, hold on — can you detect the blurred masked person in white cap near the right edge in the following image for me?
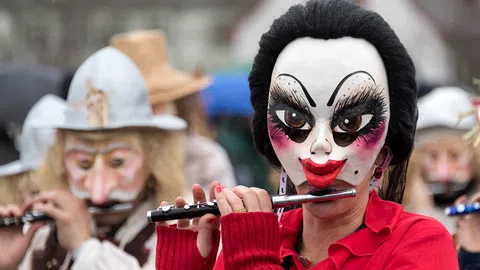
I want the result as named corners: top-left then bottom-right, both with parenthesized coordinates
top-left (404, 87), bottom-right (480, 234)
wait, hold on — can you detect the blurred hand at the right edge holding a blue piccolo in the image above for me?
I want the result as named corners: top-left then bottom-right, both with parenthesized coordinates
top-left (455, 192), bottom-right (480, 252)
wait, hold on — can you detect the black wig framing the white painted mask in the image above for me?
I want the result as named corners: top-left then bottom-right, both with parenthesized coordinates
top-left (249, 0), bottom-right (418, 203)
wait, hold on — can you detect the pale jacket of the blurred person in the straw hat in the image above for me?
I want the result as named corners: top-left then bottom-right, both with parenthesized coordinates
top-left (184, 134), bottom-right (237, 203)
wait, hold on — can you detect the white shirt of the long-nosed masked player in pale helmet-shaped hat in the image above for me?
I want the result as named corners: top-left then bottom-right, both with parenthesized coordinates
top-left (18, 199), bottom-right (158, 270)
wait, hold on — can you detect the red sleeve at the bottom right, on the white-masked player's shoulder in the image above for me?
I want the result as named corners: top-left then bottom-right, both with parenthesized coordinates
top-left (384, 219), bottom-right (459, 270)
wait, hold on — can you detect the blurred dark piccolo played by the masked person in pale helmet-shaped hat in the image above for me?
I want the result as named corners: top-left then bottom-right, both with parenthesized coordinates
top-left (0, 203), bottom-right (133, 228)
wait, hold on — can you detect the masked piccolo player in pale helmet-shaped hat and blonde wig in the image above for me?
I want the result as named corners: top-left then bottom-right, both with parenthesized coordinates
top-left (0, 47), bottom-right (186, 270)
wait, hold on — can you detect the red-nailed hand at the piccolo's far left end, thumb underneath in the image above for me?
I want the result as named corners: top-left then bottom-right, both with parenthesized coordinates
top-left (157, 181), bottom-right (221, 258)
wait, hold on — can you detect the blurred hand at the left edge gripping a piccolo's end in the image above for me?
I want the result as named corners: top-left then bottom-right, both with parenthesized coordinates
top-left (0, 205), bottom-right (45, 269)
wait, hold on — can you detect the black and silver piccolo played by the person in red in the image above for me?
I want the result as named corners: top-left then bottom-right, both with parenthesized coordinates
top-left (147, 189), bottom-right (357, 222)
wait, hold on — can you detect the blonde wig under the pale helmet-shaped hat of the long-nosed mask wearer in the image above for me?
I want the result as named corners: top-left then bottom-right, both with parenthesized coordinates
top-left (37, 128), bottom-right (186, 204)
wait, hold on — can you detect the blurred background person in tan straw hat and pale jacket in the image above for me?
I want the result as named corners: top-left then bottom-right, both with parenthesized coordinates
top-left (110, 30), bottom-right (236, 202)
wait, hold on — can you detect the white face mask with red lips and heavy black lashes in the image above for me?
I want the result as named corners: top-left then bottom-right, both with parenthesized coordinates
top-left (268, 37), bottom-right (390, 188)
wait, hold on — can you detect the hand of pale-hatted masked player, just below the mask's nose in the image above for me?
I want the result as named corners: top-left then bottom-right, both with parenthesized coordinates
top-left (25, 190), bottom-right (92, 251)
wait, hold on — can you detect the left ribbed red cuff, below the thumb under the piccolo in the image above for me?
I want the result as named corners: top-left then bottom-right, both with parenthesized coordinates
top-left (155, 226), bottom-right (220, 270)
